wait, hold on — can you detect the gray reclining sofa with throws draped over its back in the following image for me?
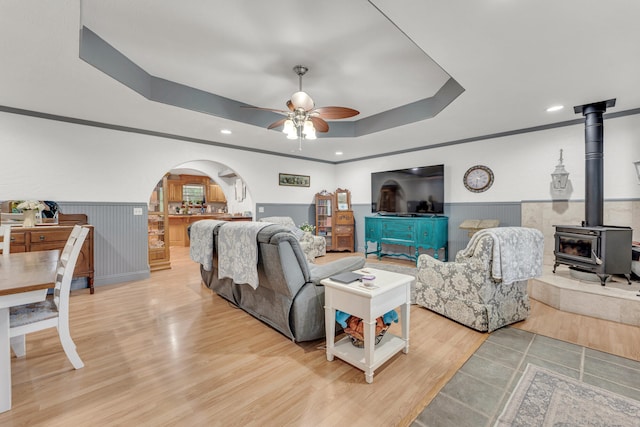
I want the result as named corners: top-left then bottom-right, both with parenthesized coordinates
top-left (189, 222), bottom-right (365, 342)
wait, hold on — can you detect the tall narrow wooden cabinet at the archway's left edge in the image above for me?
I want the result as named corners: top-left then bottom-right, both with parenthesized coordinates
top-left (148, 176), bottom-right (171, 271)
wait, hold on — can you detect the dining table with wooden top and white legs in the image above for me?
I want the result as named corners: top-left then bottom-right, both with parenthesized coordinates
top-left (0, 249), bottom-right (60, 412)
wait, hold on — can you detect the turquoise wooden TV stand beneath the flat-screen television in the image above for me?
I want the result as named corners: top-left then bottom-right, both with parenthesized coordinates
top-left (364, 215), bottom-right (449, 261)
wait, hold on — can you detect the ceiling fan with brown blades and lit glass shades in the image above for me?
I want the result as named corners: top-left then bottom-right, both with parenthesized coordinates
top-left (250, 65), bottom-right (360, 150)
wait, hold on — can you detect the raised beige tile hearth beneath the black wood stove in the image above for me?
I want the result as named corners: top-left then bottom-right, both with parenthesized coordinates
top-left (529, 265), bottom-right (640, 326)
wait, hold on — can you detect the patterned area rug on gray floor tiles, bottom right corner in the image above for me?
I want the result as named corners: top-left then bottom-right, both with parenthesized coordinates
top-left (495, 364), bottom-right (640, 427)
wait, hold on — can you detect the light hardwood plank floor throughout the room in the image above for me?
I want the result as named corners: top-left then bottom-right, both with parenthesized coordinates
top-left (0, 248), bottom-right (640, 426)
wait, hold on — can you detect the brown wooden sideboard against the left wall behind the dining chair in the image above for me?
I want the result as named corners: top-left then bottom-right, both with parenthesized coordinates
top-left (11, 224), bottom-right (94, 293)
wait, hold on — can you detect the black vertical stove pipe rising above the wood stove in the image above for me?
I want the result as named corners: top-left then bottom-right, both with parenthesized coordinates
top-left (573, 99), bottom-right (616, 227)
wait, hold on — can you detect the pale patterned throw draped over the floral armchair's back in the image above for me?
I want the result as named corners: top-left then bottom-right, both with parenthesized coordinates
top-left (464, 227), bottom-right (544, 284)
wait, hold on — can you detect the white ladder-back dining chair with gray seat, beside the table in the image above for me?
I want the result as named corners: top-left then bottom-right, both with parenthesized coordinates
top-left (9, 226), bottom-right (89, 369)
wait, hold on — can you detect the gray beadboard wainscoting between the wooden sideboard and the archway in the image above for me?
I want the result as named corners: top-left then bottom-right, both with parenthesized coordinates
top-left (57, 202), bottom-right (149, 286)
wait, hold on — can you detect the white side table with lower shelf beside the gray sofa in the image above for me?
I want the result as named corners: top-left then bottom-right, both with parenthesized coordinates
top-left (321, 268), bottom-right (414, 383)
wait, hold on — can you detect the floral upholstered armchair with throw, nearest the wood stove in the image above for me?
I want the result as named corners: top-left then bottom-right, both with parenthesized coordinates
top-left (415, 227), bottom-right (543, 332)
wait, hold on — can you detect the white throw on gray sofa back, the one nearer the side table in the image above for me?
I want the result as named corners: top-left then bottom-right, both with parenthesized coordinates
top-left (218, 221), bottom-right (271, 289)
